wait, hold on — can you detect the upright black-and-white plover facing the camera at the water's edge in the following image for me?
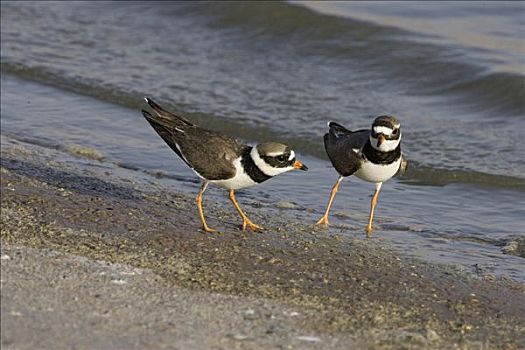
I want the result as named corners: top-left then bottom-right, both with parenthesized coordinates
top-left (316, 115), bottom-right (407, 237)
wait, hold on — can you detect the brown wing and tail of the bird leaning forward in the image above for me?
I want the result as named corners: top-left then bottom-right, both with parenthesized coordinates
top-left (142, 100), bottom-right (248, 180)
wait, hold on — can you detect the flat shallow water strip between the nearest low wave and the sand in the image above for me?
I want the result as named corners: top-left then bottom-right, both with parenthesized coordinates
top-left (1, 75), bottom-right (525, 281)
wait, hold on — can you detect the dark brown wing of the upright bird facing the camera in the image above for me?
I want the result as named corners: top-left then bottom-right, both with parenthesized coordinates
top-left (324, 122), bottom-right (370, 176)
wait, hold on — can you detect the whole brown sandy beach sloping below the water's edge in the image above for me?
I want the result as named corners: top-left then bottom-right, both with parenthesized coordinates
top-left (1, 135), bottom-right (525, 349)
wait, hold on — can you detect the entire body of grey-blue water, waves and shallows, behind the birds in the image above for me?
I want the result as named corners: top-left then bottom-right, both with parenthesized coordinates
top-left (1, 2), bottom-right (525, 281)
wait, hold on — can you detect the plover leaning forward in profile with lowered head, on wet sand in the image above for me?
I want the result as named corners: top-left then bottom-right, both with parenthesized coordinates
top-left (142, 98), bottom-right (308, 232)
